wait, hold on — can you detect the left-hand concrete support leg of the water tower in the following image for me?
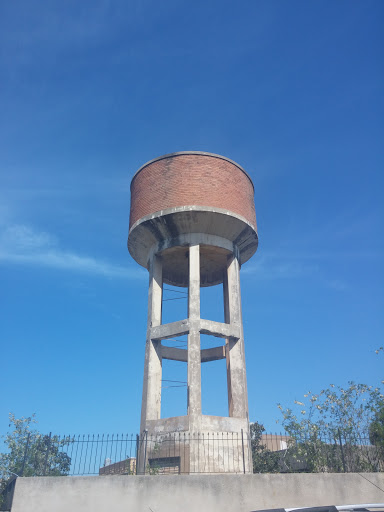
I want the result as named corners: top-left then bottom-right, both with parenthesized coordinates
top-left (140, 255), bottom-right (163, 434)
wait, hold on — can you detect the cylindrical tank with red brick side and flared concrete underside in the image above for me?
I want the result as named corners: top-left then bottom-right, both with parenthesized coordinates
top-left (128, 151), bottom-right (258, 286)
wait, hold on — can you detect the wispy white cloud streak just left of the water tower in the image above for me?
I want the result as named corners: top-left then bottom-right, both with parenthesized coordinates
top-left (0, 224), bottom-right (144, 279)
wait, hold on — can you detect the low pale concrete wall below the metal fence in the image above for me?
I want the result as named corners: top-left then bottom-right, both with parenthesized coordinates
top-left (12, 473), bottom-right (384, 512)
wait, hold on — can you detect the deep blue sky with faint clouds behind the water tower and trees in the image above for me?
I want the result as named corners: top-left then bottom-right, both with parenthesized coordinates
top-left (0, 0), bottom-right (384, 434)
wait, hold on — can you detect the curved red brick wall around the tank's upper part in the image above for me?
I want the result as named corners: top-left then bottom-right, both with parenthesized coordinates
top-left (129, 154), bottom-right (256, 227)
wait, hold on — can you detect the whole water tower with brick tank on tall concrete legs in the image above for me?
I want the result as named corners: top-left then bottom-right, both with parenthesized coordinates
top-left (128, 151), bottom-right (258, 473)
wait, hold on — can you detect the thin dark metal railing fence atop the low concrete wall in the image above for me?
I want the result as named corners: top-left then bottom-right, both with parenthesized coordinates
top-left (1, 432), bottom-right (384, 476)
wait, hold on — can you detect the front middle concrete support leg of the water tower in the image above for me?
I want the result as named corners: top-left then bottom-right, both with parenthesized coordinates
top-left (188, 245), bottom-right (201, 431)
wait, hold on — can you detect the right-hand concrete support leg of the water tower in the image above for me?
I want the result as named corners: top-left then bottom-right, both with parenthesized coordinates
top-left (224, 255), bottom-right (248, 419)
